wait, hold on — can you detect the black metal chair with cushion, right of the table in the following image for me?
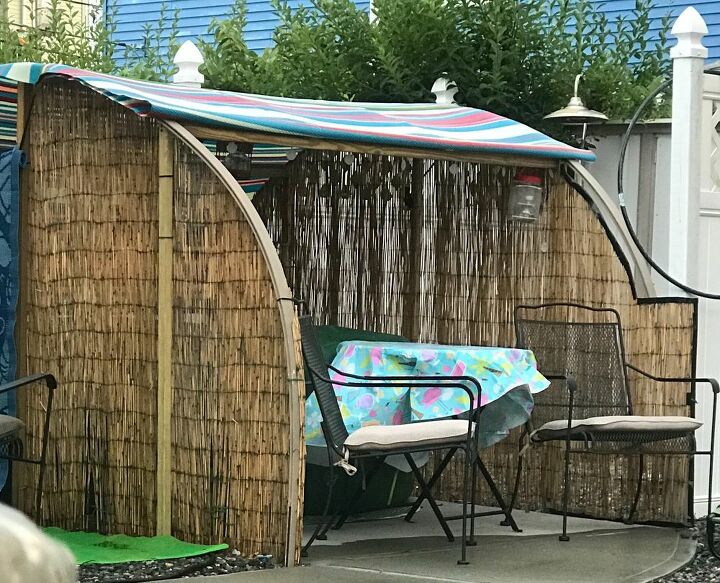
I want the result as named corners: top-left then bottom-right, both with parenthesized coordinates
top-left (511, 302), bottom-right (720, 541)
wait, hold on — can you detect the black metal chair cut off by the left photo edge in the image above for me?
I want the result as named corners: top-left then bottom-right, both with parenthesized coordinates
top-left (0, 373), bottom-right (57, 520)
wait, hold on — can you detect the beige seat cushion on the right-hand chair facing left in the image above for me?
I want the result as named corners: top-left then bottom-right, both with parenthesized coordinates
top-left (530, 415), bottom-right (702, 441)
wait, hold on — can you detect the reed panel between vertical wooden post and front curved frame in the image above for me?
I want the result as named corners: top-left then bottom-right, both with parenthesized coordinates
top-left (172, 142), bottom-right (294, 557)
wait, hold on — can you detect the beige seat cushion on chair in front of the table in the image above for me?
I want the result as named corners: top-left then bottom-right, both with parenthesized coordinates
top-left (345, 419), bottom-right (474, 453)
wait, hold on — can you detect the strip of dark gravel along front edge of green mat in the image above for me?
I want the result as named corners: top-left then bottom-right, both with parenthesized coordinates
top-left (80, 550), bottom-right (274, 583)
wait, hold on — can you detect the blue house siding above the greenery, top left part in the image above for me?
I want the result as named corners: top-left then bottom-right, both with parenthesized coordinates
top-left (111, 0), bottom-right (370, 51)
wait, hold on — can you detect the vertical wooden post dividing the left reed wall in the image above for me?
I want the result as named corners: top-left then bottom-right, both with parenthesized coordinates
top-left (156, 128), bottom-right (175, 535)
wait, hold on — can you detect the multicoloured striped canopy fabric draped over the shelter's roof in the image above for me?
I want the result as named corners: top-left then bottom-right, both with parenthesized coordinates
top-left (0, 63), bottom-right (595, 161)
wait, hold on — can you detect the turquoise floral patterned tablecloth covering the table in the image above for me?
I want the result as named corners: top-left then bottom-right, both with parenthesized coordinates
top-left (305, 341), bottom-right (550, 447)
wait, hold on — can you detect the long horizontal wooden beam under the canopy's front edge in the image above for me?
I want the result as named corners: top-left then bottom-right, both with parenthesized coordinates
top-left (185, 124), bottom-right (559, 168)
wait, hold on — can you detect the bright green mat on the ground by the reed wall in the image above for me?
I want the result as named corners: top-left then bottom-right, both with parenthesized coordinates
top-left (43, 527), bottom-right (228, 565)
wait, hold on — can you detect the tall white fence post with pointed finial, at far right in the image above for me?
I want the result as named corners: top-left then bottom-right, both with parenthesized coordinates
top-left (653, 7), bottom-right (708, 295)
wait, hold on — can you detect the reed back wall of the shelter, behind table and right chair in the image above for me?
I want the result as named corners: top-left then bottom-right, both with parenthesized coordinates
top-left (254, 151), bottom-right (695, 522)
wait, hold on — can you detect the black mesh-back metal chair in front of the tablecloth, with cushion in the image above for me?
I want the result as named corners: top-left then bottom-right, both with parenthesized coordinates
top-left (300, 316), bottom-right (517, 564)
